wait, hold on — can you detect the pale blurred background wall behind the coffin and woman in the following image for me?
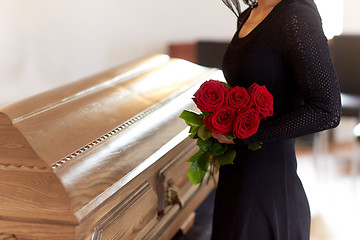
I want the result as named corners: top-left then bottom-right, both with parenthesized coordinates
top-left (0, 0), bottom-right (360, 105)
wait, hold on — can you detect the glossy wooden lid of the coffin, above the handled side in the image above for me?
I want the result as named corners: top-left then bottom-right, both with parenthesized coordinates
top-left (0, 55), bottom-right (222, 225)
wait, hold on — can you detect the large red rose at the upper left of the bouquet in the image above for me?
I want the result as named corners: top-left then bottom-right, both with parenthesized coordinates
top-left (193, 80), bottom-right (228, 112)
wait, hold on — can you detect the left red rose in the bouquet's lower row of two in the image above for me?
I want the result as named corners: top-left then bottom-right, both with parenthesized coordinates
top-left (204, 105), bottom-right (235, 135)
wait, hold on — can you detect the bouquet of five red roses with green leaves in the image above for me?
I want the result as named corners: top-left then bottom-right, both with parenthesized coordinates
top-left (180, 80), bottom-right (273, 185)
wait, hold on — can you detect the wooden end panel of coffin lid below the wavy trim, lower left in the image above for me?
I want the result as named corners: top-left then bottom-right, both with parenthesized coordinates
top-left (0, 169), bottom-right (78, 225)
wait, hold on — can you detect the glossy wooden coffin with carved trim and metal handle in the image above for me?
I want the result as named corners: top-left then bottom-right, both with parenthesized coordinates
top-left (0, 55), bottom-right (223, 240)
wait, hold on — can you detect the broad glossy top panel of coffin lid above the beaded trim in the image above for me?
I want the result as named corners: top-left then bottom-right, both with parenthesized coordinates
top-left (0, 56), bottom-right (213, 166)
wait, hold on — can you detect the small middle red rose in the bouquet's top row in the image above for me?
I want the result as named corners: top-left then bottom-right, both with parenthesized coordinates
top-left (228, 86), bottom-right (251, 111)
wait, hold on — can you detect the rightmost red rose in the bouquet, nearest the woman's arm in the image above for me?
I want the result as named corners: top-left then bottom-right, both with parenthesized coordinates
top-left (249, 83), bottom-right (273, 118)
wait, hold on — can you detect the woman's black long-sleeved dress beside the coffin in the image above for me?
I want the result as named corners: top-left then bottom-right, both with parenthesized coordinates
top-left (212, 0), bottom-right (341, 240)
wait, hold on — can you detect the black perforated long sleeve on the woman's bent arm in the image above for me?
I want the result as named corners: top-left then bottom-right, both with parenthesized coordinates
top-left (235, 2), bottom-right (341, 144)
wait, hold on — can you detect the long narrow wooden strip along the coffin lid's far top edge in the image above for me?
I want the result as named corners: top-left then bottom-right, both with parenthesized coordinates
top-left (1, 54), bottom-right (170, 120)
